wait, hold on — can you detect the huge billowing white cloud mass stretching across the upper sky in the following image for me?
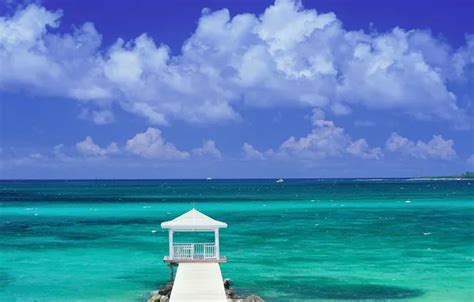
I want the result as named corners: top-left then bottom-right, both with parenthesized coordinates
top-left (0, 0), bottom-right (474, 127)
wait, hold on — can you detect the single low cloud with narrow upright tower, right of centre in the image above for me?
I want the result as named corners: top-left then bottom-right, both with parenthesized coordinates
top-left (277, 108), bottom-right (383, 160)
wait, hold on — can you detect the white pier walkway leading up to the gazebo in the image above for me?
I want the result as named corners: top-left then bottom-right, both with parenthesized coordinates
top-left (170, 262), bottom-right (227, 302)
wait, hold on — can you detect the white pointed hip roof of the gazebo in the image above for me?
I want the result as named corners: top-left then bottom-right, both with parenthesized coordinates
top-left (161, 209), bottom-right (227, 230)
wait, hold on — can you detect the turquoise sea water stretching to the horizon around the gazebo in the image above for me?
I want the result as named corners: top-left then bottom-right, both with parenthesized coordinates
top-left (0, 179), bottom-right (474, 301)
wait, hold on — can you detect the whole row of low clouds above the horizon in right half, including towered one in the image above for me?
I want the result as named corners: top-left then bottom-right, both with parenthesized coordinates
top-left (242, 108), bottom-right (462, 162)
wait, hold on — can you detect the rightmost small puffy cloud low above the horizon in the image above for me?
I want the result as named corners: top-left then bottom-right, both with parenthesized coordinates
top-left (385, 132), bottom-right (456, 160)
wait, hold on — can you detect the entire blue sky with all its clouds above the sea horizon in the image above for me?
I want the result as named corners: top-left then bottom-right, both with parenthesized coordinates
top-left (0, 0), bottom-right (474, 179)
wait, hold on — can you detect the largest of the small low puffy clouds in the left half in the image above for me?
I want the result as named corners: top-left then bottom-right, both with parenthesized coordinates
top-left (126, 127), bottom-right (189, 160)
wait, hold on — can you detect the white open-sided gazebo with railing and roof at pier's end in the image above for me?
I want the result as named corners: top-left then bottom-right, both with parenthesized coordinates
top-left (161, 208), bottom-right (227, 263)
